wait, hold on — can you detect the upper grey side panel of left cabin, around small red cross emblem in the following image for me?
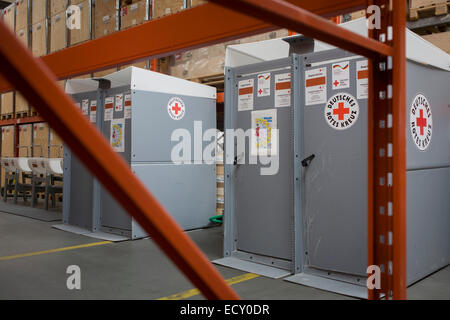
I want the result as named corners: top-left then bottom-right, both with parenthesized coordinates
top-left (132, 90), bottom-right (216, 162)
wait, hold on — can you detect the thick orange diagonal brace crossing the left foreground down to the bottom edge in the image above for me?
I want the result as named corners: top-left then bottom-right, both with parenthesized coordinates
top-left (0, 21), bottom-right (238, 299)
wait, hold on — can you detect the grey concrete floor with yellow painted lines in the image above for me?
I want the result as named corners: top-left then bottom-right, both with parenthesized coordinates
top-left (0, 212), bottom-right (450, 299)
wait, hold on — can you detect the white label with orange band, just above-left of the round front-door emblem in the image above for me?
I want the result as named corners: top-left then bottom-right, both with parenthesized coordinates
top-left (305, 68), bottom-right (327, 106)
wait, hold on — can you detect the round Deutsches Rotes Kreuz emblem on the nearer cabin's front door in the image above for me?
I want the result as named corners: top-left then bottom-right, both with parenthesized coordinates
top-left (324, 93), bottom-right (359, 130)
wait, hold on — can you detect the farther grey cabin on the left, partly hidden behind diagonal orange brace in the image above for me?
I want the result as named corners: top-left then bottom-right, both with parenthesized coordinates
top-left (56, 67), bottom-right (216, 239)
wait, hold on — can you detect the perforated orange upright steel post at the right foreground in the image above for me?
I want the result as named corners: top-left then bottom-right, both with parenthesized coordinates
top-left (368, 0), bottom-right (406, 299)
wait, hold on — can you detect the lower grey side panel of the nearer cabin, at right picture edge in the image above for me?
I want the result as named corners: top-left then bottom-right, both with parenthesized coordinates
top-left (406, 166), bottom-right (450, 285)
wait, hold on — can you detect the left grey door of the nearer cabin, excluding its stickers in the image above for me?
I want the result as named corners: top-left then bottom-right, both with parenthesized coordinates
top-left (227, 58), bottom-right (294, 260)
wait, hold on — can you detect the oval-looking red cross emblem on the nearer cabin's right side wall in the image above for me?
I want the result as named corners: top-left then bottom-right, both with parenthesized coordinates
top-left (409, 94), bottom-right (433, 151)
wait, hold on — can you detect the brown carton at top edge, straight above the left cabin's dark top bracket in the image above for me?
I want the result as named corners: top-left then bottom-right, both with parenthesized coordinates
top-left (95, 0), bottom-right (117, 38)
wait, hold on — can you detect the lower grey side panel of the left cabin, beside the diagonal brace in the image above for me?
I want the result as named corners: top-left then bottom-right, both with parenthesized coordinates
top-left (131, 163), bottom-right (216, 230)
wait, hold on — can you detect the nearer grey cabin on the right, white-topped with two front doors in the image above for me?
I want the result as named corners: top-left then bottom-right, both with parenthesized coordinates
top-left (215, 19), bottom-right (450, 297)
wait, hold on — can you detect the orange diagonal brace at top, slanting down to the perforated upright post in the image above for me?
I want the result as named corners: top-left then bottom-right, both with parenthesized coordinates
top-left (210, 0), bottom-right (393, 58)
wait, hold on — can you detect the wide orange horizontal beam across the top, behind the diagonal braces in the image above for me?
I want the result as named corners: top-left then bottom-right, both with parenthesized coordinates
top-left (0, 0), bottom-right (365, 93)
